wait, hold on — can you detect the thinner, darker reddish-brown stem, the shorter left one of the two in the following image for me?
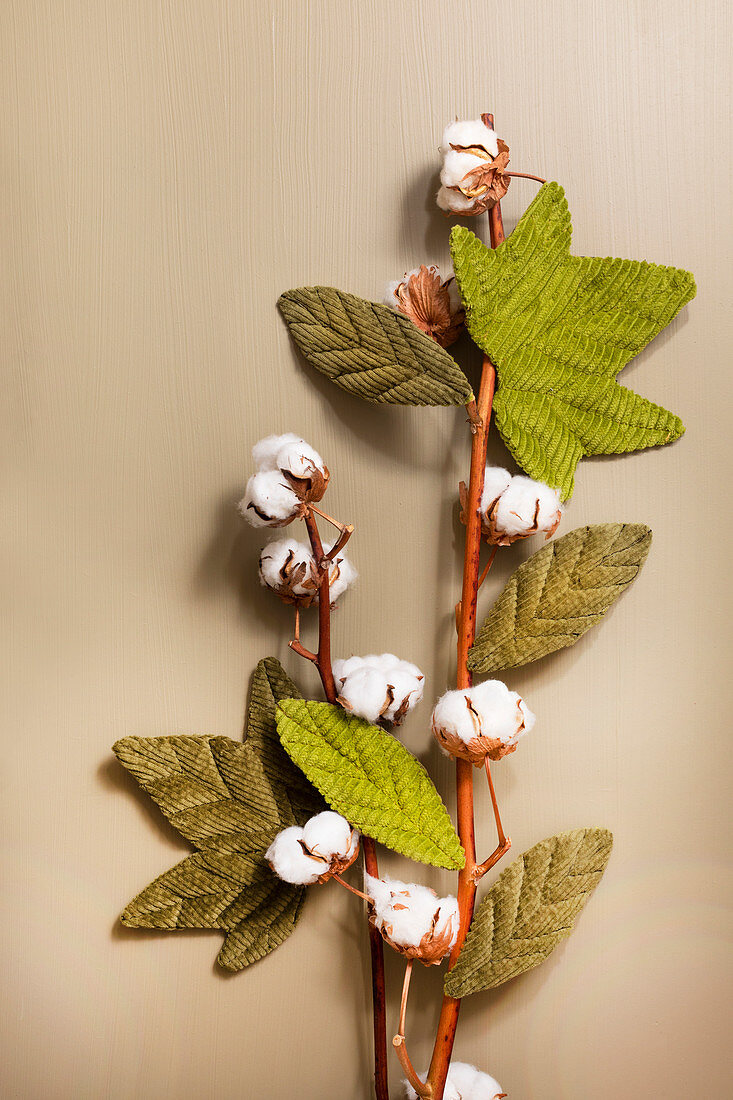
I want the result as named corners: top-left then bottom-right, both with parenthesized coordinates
top-left (304, 510), bottom-right (390, 1100)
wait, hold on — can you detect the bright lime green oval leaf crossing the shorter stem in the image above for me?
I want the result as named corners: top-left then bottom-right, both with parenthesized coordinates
top-left (277, 699), bottom-right (466, 868)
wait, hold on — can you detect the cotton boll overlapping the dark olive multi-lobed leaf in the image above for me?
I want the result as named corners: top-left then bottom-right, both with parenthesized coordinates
top-left (265, 810), bottom-right (359, 886)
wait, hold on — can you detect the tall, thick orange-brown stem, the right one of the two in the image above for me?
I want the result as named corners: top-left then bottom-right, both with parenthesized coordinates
top-left (427, 114), bottom-right (506, 1100)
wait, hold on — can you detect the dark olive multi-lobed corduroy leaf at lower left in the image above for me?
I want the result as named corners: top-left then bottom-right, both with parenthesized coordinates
top-left (113, 658), bottom-right (326, 970)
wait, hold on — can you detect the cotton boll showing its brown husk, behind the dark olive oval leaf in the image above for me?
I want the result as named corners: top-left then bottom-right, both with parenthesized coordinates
top-left (384, 264), bottom-right (466, 348)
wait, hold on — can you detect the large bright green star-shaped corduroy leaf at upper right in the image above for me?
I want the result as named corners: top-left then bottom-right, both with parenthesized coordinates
top-left (451, 183), bottom-right (696, 499)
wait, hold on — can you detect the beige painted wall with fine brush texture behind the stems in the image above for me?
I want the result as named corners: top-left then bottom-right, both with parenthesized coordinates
top-left (0, 0), bottom-right (733, 1100)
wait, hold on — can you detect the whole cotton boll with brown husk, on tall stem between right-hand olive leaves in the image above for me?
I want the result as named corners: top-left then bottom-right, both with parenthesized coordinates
top-left (433, 680), bottom-right (535, 768)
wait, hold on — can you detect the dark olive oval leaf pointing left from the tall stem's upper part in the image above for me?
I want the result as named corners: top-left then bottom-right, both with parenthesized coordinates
top-left (277, 286), bottom-right (473, 405)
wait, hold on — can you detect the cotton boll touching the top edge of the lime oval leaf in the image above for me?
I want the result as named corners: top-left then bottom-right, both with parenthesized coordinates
top-left (333, 653), bottom-right (425, 726)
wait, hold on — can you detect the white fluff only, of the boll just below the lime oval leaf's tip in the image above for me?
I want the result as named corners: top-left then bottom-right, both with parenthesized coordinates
top-left (364, 875), bottom-right (459, 955)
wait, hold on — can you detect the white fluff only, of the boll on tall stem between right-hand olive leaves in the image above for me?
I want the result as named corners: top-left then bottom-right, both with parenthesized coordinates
top-left (433, 680), bottom-right (536, 745)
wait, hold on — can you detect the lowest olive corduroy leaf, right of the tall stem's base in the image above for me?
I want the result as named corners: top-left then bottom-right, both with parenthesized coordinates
top-left (445, 828), bottom-right (613, 998)
